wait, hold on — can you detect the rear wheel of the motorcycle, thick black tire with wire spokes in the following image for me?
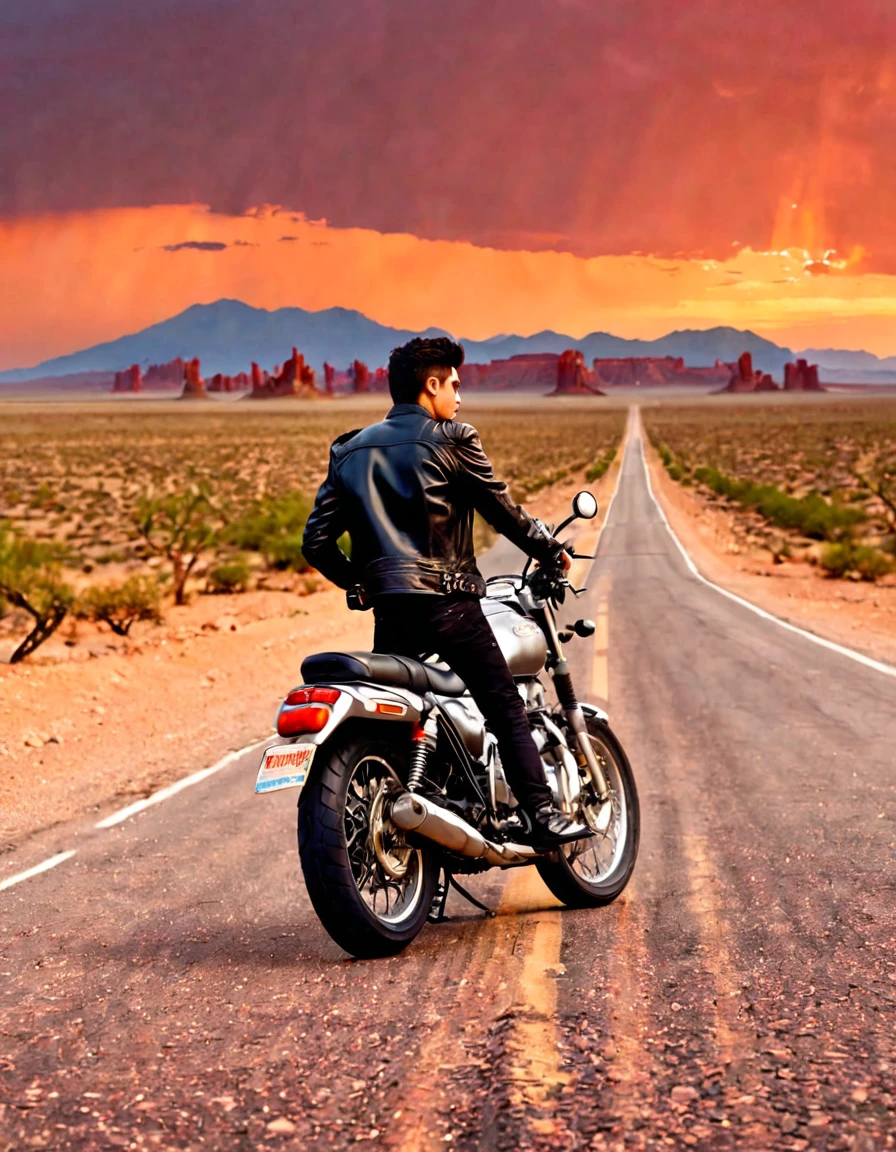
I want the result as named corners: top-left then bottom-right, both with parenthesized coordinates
top-left (298, 729), bottom-right (439, 960)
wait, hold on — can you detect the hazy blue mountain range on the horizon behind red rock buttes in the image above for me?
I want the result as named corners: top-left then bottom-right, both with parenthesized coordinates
top-left (0, 300), bottom-right (896, 384)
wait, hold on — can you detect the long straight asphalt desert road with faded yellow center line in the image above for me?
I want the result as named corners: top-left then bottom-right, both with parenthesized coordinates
top-left (0, 419), bottom-right (896, 1152)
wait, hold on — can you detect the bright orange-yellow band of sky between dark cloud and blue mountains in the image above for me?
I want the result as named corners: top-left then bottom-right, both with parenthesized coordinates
top-left (0, 205), bottom-right (896, 367)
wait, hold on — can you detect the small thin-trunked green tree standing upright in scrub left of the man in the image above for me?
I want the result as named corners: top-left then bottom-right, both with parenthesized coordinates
top-left (134, 483), bottom-right (219, 605)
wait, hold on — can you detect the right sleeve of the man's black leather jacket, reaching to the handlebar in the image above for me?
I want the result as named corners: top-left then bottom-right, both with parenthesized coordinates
top-left (451, 424), bottom-right (563, 563)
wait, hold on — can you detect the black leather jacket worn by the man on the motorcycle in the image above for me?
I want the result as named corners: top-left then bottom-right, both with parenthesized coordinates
top-left (302, 404), bottom-right (562, 599)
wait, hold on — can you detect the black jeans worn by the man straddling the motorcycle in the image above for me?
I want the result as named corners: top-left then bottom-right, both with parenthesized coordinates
top-left (373, 593), bottom-right (553, 812)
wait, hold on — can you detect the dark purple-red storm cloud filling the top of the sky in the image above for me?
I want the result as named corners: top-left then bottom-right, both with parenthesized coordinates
top-left (0, 0), bottom-right (896, 266)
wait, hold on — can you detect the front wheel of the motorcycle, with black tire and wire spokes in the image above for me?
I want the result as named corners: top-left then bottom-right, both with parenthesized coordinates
top-left (536, 715), bottom-right (640, 908)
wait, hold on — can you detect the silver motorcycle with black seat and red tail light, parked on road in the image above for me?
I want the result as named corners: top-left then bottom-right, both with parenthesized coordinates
top-left (256, 492), bottom-right (639, 958)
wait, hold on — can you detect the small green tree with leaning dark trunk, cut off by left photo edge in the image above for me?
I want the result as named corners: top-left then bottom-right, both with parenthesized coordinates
top-left (0, 524), bottom-right (75, 664)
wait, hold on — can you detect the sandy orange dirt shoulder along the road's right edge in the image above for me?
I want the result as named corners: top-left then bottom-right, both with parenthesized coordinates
top-left (644, 440), bottom-right (896, 665)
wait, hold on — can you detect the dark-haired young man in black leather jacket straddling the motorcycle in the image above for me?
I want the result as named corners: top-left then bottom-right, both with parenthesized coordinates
top-left (303, 336), bottom-right (590, 848)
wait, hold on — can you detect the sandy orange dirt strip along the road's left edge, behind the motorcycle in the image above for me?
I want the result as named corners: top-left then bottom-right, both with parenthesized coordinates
top-left (0, 463), bottom-right (618, 852)
